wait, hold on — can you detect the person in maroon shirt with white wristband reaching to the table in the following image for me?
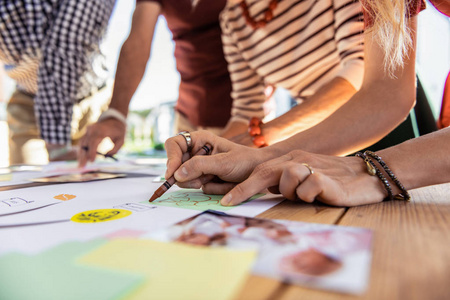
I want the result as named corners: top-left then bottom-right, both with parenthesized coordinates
top-left (79, 0), bottom-right (232, 166)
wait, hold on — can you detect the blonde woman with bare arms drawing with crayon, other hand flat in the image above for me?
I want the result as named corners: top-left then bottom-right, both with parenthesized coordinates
top-left (166, 0), bottom-right (450, 206)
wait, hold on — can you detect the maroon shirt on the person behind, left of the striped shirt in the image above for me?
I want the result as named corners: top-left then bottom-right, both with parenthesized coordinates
top-left (136, 0), bottom-right (232, 127)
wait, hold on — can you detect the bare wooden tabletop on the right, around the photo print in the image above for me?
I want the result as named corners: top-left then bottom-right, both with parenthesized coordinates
top-left (236, 183), bottom-right (450, 300)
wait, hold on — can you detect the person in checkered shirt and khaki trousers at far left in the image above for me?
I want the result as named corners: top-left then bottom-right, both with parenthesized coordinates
top-left (0, 0), bottom-right (115, 164)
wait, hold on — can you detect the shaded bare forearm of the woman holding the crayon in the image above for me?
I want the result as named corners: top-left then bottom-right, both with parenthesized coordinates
top-left (279, 80), bottom-right (414, 155)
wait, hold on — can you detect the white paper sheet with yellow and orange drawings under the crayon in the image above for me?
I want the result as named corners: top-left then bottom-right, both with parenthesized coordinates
top-left (0, 177), bottom-right (282, 254)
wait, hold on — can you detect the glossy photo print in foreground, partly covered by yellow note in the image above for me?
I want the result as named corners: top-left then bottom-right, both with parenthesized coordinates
top-left (147, 211), bottom-right (372, 293)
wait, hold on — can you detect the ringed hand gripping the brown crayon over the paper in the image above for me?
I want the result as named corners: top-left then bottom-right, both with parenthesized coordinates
top-left (165, 131), bottom-right (272, 194)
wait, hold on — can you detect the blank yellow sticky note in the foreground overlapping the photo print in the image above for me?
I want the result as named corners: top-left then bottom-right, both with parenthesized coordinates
top-left (80, 239), bottom-right (256, 300)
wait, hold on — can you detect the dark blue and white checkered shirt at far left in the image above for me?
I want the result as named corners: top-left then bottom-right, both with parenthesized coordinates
top-left (0, 0), bottom-right (115, 144)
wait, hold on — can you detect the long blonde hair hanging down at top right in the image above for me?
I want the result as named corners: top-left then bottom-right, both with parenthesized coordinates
top-left (361, 0), bottom-right (415, 76)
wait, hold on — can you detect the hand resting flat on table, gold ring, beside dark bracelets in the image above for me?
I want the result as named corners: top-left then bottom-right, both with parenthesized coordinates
top-left (221, 150), bottom-right (387, 206)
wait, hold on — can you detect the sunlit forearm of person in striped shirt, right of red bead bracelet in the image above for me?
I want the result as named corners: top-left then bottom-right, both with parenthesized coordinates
top-left (262, 77), bottom-right (356, 144)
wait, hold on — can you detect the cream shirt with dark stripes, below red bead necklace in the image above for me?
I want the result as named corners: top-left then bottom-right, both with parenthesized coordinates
top-left (220, 0), bottom-right (364, 121)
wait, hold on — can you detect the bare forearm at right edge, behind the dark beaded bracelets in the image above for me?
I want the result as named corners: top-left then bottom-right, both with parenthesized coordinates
top-left (377, 128), bottom-right (450, 189)
